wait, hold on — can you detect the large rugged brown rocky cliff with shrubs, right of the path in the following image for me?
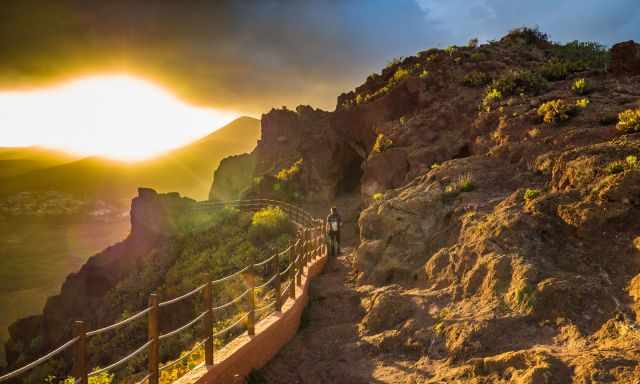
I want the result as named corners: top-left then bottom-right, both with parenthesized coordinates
top-left (213, 29), bottom-right (640, 383)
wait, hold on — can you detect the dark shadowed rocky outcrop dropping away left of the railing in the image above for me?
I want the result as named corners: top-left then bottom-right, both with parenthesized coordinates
top-left (6, 188), bottom-right (194, 367)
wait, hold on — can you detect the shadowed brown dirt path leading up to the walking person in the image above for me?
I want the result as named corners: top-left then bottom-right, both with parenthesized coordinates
top-left (262, 248), bottom-right (372, 384)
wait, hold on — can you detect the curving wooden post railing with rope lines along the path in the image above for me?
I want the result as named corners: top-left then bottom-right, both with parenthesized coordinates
top-left (0, 199), bottom-right (326, 384)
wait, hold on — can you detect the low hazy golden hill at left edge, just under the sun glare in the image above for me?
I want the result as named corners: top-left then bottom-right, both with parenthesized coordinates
top-left (0, 147), bottom-right (78, 179)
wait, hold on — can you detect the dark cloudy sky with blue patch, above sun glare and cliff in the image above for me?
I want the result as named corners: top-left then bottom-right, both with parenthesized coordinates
top-left (0, 0), bottom-right (640, 158)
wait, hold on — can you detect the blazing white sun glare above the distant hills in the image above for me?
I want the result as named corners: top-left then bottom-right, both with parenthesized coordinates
top-left (0, 75), bottom-right (237, 161)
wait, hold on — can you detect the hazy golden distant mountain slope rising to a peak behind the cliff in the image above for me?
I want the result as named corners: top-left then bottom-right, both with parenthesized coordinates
top-left (0, 117), bottom-right (260, 204)
